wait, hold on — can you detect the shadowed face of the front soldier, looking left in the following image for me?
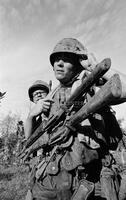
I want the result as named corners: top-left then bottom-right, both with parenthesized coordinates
top-left (53, 53), bottom-right (76, 84)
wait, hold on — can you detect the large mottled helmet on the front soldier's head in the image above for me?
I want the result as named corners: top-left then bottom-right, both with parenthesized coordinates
top-left (50, 38), bottom-right (88, 66)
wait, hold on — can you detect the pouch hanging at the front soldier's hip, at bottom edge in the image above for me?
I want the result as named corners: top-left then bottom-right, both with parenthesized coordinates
top-left (71, 179), bottom-right (94, 200)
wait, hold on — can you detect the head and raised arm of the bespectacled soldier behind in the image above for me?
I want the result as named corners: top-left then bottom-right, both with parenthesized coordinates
top-left (25, 80), bottom-right (51, 139)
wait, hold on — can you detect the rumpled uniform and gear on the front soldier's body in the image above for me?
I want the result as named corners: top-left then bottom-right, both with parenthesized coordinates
top-left (28, 81), bottom-right (120, 200)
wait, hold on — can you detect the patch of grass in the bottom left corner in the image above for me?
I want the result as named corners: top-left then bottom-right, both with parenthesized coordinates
top-left (0, 166), bottom-right (28, 200)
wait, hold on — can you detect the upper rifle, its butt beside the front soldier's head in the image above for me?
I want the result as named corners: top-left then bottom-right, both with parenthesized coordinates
top-left (18, 58), bottom-right (111, 159)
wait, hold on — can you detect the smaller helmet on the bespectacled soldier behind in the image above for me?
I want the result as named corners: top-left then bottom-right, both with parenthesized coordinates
top-left (28, 80), bottom-right (49, 101)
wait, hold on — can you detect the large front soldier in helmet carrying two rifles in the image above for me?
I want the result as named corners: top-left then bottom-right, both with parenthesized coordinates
top-left (25, 38), bottom-right (126, 200)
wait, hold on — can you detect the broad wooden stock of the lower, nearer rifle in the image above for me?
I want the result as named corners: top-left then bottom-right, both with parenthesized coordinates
top-left (69, 74), bottom-right (122, 126)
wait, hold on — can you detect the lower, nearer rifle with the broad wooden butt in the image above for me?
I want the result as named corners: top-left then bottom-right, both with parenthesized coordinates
top-left (21, 74), bottom-right (122, 159)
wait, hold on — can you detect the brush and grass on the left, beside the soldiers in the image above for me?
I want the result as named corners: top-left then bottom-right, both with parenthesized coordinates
top-left (0, 113), bottom-right (29, 200)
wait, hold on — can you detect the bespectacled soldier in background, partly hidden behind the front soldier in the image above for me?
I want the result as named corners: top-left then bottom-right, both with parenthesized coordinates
top-left (25, 80), bottom-right (53, 200)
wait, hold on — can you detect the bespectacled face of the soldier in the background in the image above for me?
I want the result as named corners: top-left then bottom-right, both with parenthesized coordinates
top-left (32, 89), bottom-right (47, 103)
